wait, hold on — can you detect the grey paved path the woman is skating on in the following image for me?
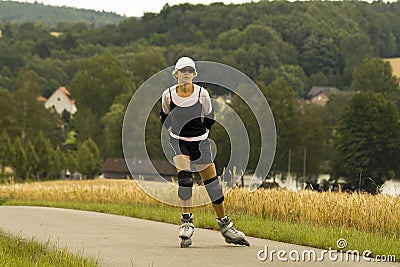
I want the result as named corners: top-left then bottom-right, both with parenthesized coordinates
top-left (0, 206), bottom-right (400, 267)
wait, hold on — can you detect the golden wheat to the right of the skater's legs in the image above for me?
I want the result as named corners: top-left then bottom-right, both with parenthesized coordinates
top-left (226, 189), bottom-right (400, 238)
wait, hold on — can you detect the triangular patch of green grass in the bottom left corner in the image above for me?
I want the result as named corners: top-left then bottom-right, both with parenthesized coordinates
top-left (0, 230), bottom-right (98, 267)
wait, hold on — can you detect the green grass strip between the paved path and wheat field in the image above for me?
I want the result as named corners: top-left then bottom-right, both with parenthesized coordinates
top-left (3, 200), bottom-right (400, 261)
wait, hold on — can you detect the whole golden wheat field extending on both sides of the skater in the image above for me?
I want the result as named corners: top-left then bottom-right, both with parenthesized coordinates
top-left (0, 179), bottom-right (400, 239)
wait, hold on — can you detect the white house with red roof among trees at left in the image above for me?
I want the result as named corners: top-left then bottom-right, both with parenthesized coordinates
top-left (44, 87), bottom-right (77, 115)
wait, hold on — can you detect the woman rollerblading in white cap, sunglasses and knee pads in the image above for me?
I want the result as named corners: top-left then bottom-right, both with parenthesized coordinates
top-left (160, 57), bottom-right (249, 247)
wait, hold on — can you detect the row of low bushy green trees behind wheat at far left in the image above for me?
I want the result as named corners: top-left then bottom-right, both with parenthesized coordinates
top-left (0, 131), bottom-right (103, 180)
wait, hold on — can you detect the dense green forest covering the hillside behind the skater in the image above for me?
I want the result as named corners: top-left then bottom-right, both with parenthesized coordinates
top-left (0, 1), bottom-right (400, 191)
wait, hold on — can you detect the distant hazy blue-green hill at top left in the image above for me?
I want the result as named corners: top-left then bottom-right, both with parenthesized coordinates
top-left (0, 1), bottom-right (125, 26)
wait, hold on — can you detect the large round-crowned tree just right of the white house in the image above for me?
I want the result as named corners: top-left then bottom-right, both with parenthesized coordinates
top-left (70, 53), bottom-right (133, 149)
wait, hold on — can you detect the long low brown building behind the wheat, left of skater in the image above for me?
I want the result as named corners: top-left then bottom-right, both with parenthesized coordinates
top-left (103, 158), bottom-right (177, 182)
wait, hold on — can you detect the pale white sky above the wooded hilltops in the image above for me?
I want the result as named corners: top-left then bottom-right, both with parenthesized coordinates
top-left (10, 0), bottom-right (258, 17)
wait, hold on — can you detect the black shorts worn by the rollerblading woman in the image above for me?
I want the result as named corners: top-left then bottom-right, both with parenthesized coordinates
top-left (169, 137), bottom-right (213, 164)
